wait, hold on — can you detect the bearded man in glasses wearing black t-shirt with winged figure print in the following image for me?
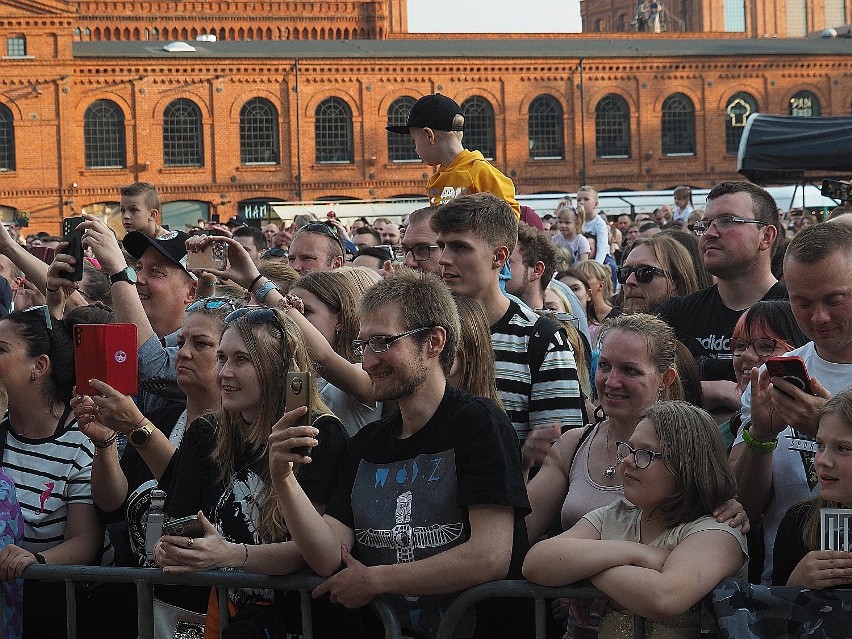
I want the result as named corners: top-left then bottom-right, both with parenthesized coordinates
top-left (269, 269), bottom-right (529, 637)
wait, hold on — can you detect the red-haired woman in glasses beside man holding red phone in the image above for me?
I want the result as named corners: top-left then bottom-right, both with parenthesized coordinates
top-left (719, 300), bottom-right (810, 452)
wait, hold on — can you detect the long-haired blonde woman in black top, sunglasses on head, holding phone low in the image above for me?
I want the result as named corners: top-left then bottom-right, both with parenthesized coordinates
top-left (154, 307), bottom-right (348, 637)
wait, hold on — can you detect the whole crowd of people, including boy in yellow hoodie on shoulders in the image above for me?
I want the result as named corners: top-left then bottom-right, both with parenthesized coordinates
top-left (0, 94), bottom-right (852, 639)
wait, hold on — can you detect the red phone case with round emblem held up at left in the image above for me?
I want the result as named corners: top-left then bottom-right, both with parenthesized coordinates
top-left (74, 324), bottom-right (139, 395)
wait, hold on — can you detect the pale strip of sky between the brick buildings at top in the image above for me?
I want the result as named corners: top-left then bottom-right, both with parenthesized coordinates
top-left (408, 0), bottom-right (580, 33)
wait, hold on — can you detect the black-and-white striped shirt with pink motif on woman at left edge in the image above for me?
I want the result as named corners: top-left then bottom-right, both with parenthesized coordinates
top-left (0, 412), bottom-right (113, 565)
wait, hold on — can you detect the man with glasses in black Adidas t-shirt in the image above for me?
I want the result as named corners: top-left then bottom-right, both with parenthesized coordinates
top-left (657, 182), bottom-right (787, 411)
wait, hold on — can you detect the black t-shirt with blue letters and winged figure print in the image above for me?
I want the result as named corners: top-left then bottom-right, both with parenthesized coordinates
top-left (326, 386), bottom-right (530, 636)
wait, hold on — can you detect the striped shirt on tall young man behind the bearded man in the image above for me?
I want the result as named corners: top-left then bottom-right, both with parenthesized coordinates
top-left (491, 300), bottom-right (583, 442)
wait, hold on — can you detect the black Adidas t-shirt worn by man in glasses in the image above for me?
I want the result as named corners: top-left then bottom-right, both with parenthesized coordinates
top-left (655, 282), bottom-right (787, 382)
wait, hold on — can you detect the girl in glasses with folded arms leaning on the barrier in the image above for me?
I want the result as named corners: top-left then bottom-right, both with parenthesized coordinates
top-left (523, 402), bottom-right (748, 639)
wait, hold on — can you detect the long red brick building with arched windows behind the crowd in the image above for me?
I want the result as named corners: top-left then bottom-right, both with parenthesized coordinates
top-left (0, 0), bottom-right (852, 232)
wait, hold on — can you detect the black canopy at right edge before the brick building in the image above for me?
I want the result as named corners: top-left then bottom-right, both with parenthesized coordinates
top-left (737, 113), bottom-right (852, 184)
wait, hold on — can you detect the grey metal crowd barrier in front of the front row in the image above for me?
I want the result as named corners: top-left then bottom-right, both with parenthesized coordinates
top-left (6, 564), bottom-right (644, 639)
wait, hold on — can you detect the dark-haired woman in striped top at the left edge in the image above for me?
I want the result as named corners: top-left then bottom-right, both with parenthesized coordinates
top-left (0, 306), bottom-right (112, 638)
